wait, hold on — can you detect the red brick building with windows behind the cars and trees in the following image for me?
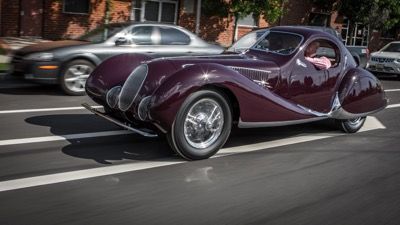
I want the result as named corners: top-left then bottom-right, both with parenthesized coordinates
top-left (0, 0), bottom-right (396, 49)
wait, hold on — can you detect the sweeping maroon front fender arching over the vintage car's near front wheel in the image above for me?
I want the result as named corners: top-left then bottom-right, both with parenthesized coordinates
top-left (149, 63), bottom-right (313, 131)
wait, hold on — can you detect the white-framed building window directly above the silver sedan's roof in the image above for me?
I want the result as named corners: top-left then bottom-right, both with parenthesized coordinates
top-left (131, 0), bottom-right (178, 23)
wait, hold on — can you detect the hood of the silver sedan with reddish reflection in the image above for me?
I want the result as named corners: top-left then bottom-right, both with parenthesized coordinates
top-left (16, 40), bottom-right (89, 55)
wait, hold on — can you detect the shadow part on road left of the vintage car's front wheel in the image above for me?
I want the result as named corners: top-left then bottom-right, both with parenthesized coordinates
top-left (25, 114), bottom-right (176, 164)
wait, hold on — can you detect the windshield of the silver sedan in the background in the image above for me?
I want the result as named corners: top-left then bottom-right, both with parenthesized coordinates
top-left (78, 24), bottom-right (125, 43)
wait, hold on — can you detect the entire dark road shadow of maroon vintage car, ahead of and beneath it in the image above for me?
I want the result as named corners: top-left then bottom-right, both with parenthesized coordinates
top-left (25, 114), bottom-right (339, 164)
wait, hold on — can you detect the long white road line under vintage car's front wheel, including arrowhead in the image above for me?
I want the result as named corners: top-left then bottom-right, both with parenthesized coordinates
top-left (0, 117), bottom-right (385, 192)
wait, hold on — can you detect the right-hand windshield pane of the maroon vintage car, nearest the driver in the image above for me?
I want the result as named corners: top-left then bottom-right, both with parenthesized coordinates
top-left (254, 31), bottom-right (303, 55)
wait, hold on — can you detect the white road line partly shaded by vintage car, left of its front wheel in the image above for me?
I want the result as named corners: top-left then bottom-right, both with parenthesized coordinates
top-left (0, 130), bottom-right (132, 146)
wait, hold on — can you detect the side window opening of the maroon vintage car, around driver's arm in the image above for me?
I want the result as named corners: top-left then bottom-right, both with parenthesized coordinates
top-left (304, 39), bottom-right (340, 67)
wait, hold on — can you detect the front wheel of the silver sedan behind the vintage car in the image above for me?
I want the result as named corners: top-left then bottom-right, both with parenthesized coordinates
top-left (60, 59), bottom-right (95, 96)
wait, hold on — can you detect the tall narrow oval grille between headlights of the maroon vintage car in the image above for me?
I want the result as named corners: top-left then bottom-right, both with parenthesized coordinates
top-left (118, 64), bottom-right (148, 111)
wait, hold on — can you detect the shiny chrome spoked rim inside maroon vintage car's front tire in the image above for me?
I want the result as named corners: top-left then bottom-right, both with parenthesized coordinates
top-left (184, 98), bottom-right (224, 149)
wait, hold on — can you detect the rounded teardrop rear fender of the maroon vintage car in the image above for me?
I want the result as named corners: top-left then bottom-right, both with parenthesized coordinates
top-left (338, 68), bottom-right (387, 116)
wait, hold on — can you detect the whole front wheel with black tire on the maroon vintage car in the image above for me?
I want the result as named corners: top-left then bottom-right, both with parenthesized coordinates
top-left (167, 90), bottom-right (232, 160)
